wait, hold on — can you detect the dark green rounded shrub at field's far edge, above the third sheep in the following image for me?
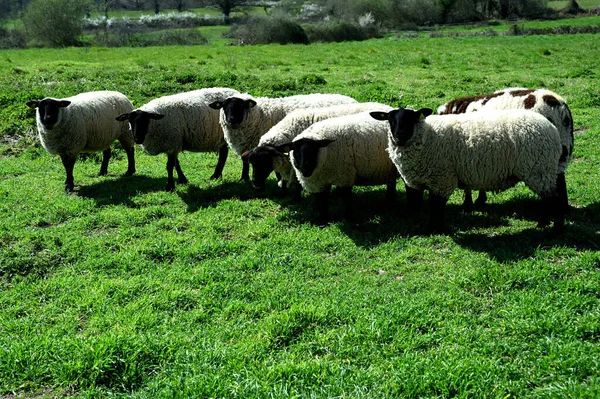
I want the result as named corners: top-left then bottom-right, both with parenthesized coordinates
top-left (225, 16), bottom-right (309, 44)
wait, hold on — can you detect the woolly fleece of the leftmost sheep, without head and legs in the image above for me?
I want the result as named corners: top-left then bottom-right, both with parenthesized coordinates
top-left (36, 91), bottom-right (133, 157)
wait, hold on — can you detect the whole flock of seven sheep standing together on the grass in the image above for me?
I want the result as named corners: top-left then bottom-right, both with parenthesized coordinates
top-left (27, 88), bottom-right (573, 234)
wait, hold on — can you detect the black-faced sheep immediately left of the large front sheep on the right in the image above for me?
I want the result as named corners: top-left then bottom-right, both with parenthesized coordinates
top-left (289, 112), bottom-right (398, 224)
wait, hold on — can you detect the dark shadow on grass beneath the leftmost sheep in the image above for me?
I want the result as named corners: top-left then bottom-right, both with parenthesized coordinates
top-left (77, 175), bottom-right (167, 207)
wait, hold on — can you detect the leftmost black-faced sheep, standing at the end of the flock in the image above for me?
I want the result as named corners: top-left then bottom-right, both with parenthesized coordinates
top-left (26, 91), bottom-right (135, 193)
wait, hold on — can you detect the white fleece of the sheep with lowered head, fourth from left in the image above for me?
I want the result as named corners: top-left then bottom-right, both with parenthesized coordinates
top-left (258, 102), bottom-right (392, 183)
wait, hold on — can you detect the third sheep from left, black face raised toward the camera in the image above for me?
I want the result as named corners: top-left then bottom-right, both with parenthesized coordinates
top-left (210, 94), bottom-right (357, 180)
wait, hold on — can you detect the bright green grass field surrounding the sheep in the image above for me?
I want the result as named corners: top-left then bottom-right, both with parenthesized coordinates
top-left (0, 35), bottom-right (600, 398)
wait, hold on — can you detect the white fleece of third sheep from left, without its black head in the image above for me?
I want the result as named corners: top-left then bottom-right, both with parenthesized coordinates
top-left (220, 94), bottom-right (357, 155)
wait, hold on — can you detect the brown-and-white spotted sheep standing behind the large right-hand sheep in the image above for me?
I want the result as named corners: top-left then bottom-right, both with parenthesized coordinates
top-left (437, 88), bottom-right (574, 210)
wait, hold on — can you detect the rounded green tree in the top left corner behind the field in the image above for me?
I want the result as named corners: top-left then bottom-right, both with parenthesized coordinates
top-left (23, 0), bottom-right (92, 47)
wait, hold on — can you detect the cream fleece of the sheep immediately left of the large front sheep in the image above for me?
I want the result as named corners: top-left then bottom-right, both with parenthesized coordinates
top-left (290, 113), bottom-right (396, 193)
